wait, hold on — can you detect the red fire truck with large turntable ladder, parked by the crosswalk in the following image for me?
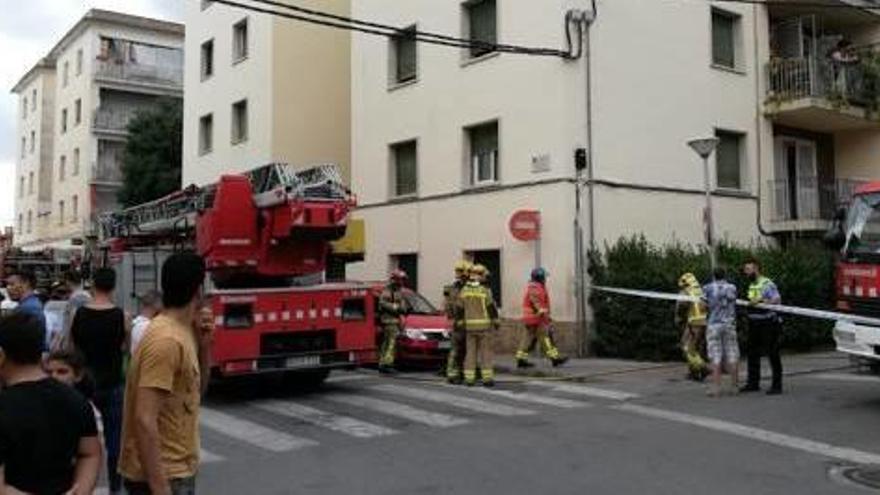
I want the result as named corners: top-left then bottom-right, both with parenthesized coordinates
top-left (100, 164), bottom-right (376, 380)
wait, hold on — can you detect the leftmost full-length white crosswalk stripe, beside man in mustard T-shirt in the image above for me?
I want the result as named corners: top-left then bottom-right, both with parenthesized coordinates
top-left (199, 407), bottom-right (318, 452)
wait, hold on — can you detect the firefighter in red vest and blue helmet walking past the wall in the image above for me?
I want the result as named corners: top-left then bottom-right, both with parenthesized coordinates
top-left (516, 268), bottom-right (568, 368)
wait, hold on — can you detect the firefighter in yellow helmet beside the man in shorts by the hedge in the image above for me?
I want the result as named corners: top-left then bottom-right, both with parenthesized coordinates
top-left (675, 273), bottom-right (709, 381)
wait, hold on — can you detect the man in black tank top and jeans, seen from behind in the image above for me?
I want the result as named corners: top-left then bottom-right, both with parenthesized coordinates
top-left (70, 268), bottom-right (128, 494)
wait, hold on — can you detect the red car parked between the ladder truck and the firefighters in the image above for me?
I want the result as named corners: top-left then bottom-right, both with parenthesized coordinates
top-left (377, 288), bottom-right (452, 368)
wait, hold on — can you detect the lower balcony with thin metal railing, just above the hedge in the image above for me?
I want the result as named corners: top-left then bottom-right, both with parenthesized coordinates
top-left (766, 177), bottom-right (865, 232)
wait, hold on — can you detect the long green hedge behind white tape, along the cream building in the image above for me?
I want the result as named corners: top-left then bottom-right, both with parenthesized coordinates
top-left (589, 237), bottom-right (834, 361)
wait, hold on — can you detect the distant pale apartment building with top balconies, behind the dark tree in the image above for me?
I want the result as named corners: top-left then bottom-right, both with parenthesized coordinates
top-left (13, 9), bottom-right (183, 249)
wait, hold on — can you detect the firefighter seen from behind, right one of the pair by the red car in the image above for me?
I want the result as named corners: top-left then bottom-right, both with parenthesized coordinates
top-left (456, 265), bottom-right (498, 387)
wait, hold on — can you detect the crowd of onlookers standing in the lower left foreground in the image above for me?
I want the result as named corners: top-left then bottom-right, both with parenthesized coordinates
top-left (0, 254), bottom-right (213, 495)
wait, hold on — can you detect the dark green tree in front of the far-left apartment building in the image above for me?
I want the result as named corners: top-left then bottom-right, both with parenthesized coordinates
top-left (118, 98), bottom-right (183, 207)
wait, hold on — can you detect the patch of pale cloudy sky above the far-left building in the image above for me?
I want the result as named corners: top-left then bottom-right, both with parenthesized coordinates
top-left (0, 0), bottom-right (184, 227)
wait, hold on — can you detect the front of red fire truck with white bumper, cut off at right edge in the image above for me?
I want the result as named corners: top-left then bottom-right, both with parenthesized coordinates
top-left (826, 181), bottom-right (880, 365)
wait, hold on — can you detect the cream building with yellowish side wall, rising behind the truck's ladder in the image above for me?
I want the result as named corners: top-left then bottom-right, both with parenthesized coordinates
top-left (183, 0), bottom-right (351, 184)
